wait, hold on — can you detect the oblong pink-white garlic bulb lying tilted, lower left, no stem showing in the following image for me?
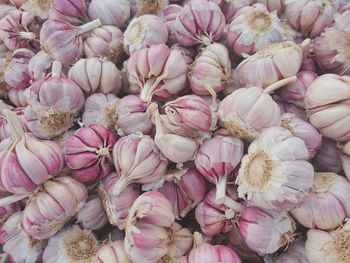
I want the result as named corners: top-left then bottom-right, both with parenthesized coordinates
top-left (23, 176), bottom-right (88, 240)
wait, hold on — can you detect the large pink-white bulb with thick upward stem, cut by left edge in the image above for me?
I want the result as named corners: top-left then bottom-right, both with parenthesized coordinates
top-left (0, 109), bottom-right (64, 194)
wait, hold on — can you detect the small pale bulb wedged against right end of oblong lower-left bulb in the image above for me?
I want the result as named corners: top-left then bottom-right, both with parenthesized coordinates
top-left (75, 195), bottom-right (108, 230)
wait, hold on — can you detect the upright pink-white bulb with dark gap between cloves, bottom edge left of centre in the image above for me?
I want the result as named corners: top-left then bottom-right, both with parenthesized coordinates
top-left (124, 191), bottom-right (175, 263)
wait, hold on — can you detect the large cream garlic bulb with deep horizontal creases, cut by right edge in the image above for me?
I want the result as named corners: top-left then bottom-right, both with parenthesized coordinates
top-left (305, 74), bottom-right (350, 142)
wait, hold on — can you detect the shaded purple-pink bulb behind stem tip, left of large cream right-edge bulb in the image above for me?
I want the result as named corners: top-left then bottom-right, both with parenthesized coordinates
top-left (279, 71), bottom-right (317, 109)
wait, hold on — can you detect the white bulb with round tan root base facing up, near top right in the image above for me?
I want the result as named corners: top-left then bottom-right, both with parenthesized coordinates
top-left (225, 4), bottom-right (286, 56)
